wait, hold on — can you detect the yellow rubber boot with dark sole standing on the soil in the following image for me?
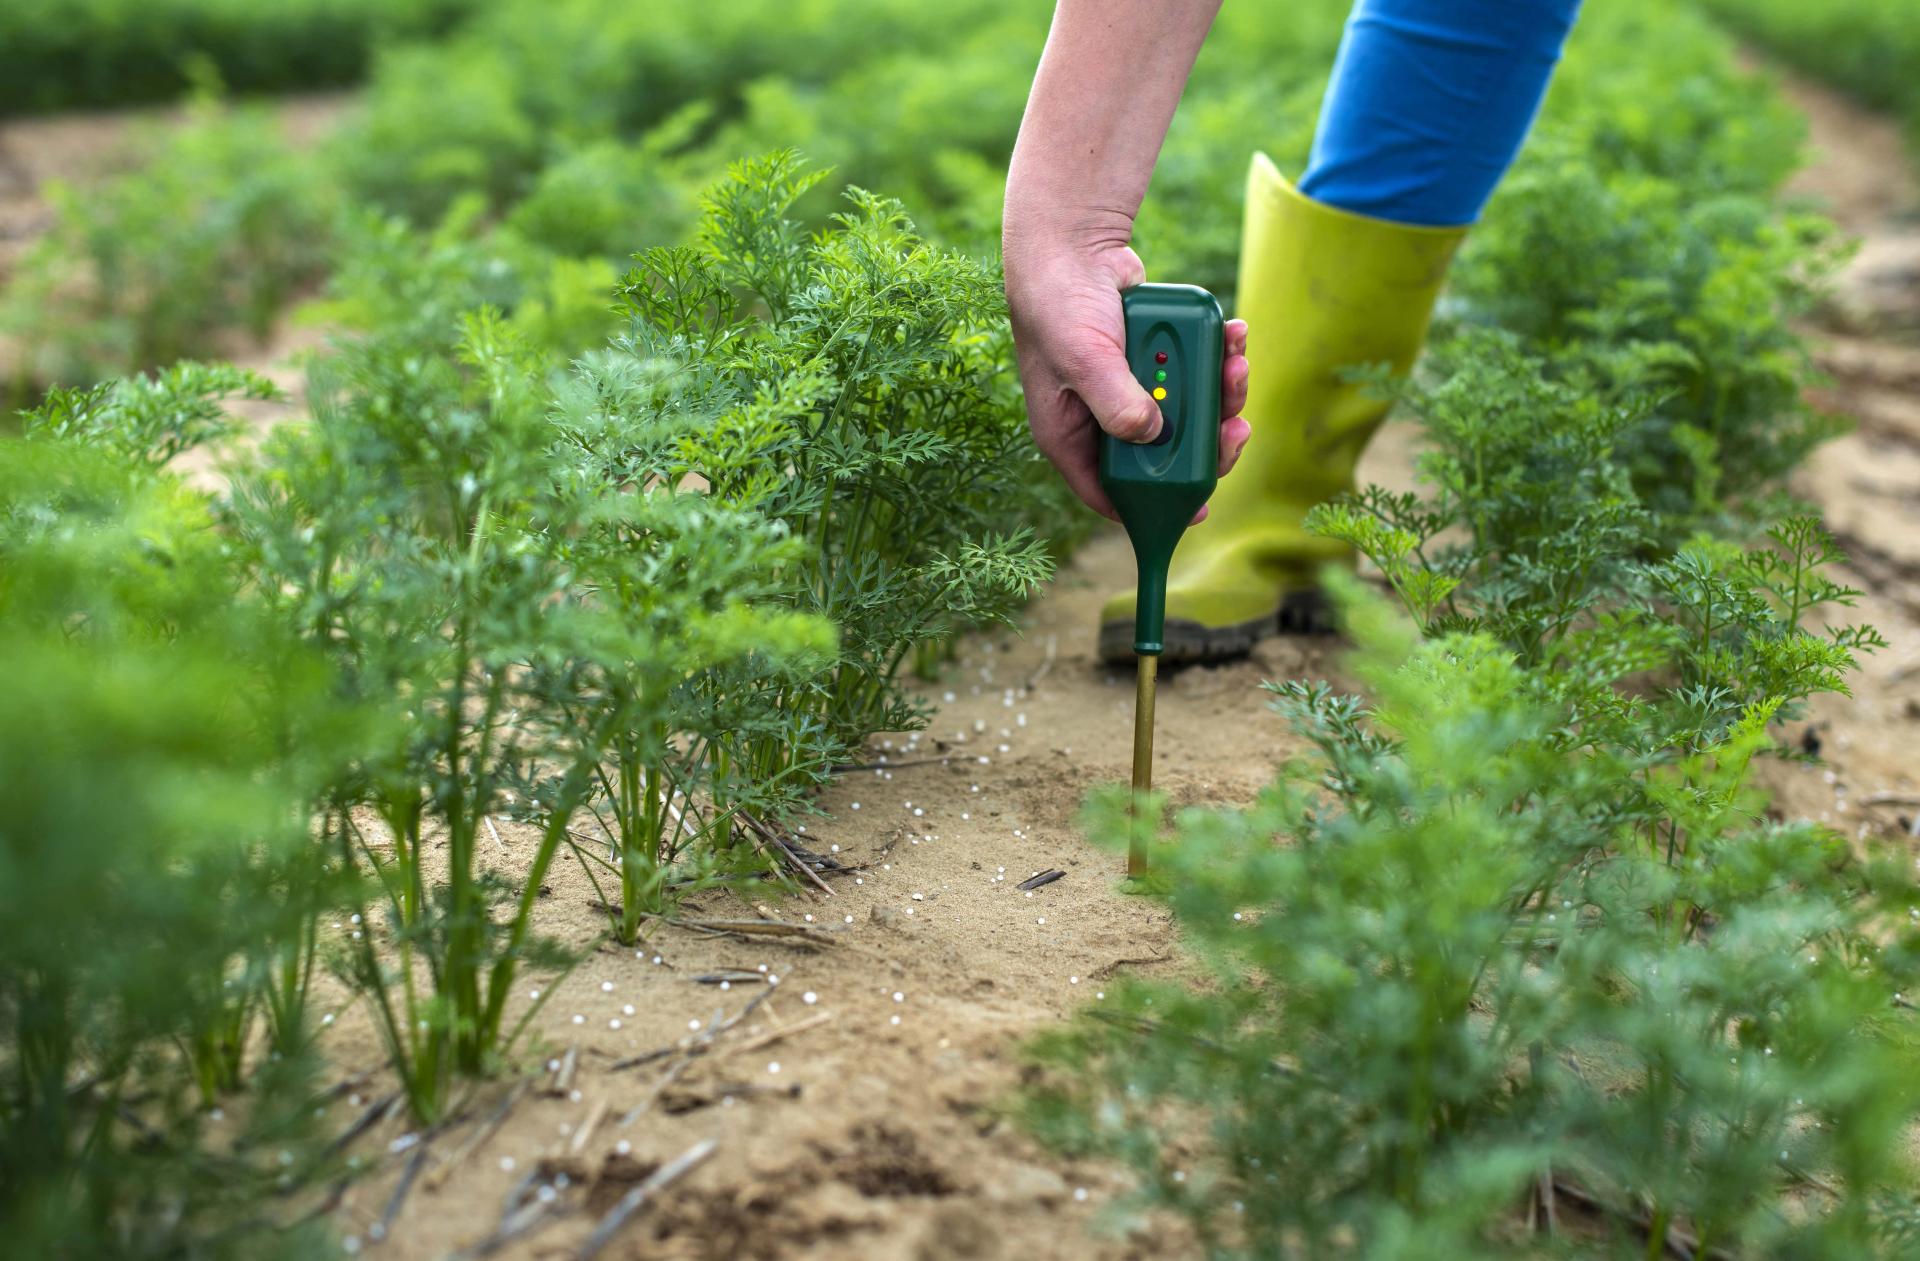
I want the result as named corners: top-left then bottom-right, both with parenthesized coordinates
top-left (1100, 154), bottom-right (1467, 662)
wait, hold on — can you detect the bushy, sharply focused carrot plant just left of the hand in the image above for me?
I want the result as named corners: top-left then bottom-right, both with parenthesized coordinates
top-left (579, 154), bottom-right (1058, 756)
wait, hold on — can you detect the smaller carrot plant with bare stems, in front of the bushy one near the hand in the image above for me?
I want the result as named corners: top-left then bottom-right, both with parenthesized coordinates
top-left (545, 489), bottom-right (833, 942)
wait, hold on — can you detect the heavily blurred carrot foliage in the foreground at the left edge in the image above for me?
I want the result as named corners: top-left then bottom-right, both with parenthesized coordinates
top-left (0, 429), bottom-right (357, 1257)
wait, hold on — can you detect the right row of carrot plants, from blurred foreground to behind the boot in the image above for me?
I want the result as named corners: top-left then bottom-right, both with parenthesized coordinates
top-left (1025, 12), bottom-right (1920, 1259)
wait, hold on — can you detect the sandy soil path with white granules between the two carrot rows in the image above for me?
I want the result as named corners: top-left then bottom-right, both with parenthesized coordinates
top-left (303, 522), bottom-right (1367, 1261)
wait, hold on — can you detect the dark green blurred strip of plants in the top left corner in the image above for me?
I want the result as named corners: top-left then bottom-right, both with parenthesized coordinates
top-left (0, 0), bottom-right (474, 117)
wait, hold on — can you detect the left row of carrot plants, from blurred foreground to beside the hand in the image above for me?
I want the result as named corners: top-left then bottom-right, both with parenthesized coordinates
top-left (0, 154), bottom-right (1071, 1257)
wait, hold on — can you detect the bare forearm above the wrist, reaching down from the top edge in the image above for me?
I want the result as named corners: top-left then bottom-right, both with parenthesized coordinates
top-left (1002, 0), bottom-right (1219, 265)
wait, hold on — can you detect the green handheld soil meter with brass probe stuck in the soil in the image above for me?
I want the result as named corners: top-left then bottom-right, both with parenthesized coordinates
top-left (1100, 284), bottom-right (1227, 875)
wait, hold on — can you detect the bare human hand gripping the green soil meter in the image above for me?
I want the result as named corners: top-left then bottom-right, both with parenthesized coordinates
top-left (1006, 235), bottom-right (1252, 522)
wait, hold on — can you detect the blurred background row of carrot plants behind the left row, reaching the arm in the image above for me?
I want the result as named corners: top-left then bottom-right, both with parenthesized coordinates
top-left (0, 0), bottom-right (1044, 397)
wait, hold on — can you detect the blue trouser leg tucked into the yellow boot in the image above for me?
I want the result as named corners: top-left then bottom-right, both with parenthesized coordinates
top-left (1300, 0), bottom-right (1580, 226)
